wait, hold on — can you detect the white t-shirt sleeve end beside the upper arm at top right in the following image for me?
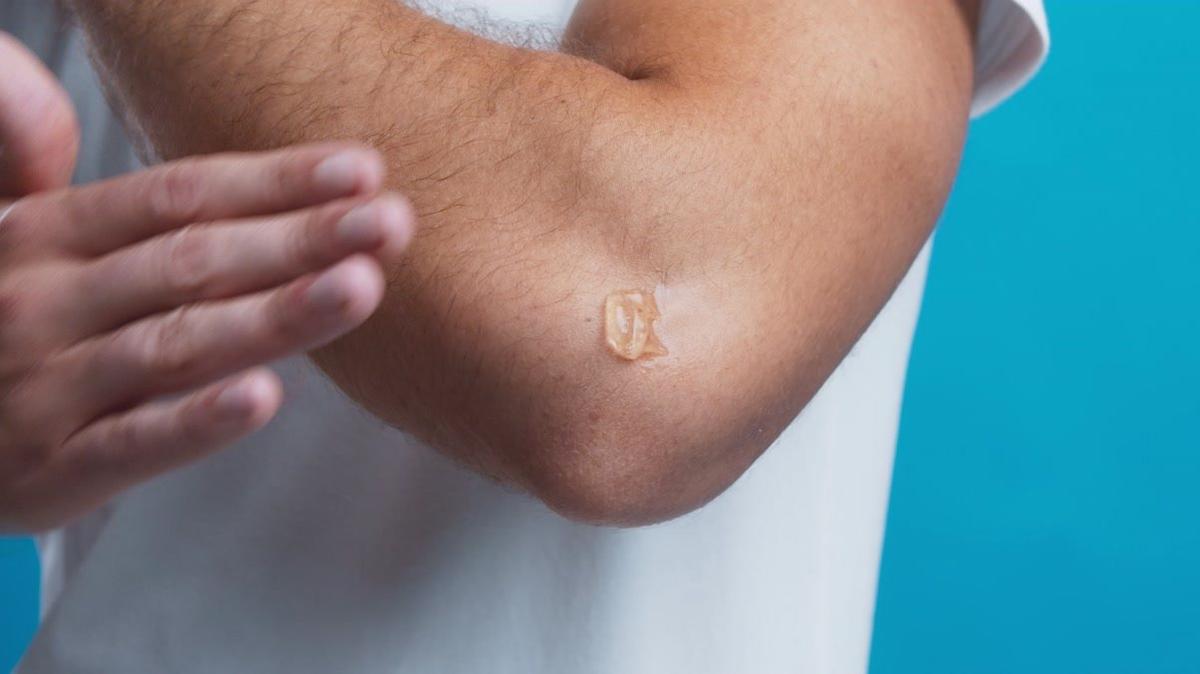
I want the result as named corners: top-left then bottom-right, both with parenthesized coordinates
top-left (971, 0), bottom-right (1050, 118)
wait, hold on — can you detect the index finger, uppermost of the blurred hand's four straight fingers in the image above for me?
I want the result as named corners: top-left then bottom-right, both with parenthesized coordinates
top-left (42, 144), bottom-right (383, 255)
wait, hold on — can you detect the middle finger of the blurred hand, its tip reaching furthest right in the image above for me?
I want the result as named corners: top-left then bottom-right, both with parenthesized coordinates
top-left (75, 194), bottom-right (414, 338)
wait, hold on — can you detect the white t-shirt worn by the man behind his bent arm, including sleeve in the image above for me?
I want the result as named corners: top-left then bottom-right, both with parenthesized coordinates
top-left (0, 0), bottom-right (1048, 674)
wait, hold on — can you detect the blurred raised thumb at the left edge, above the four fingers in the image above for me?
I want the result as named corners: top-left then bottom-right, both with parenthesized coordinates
top-left (0, 32), bottom-right (79, 198)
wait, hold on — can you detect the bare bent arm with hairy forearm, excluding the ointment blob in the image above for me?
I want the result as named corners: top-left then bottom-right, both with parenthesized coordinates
top-left (68, 0), bottom-right (978, 524)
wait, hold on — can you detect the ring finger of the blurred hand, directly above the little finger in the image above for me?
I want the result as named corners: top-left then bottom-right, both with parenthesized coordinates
top-left (56, 255), bottom-right (384, 422)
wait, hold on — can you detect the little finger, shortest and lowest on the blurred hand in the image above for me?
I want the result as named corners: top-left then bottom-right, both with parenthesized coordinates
top-left (30, 368), bottom-right (283, 522)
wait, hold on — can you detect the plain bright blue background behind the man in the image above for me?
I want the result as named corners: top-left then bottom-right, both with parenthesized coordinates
top-left (0, 0), bottom-right (1200, 674)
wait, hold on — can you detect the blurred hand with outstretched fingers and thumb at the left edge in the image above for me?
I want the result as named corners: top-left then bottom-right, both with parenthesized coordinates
top-left (0, 34), bottom-right (413, 532)
